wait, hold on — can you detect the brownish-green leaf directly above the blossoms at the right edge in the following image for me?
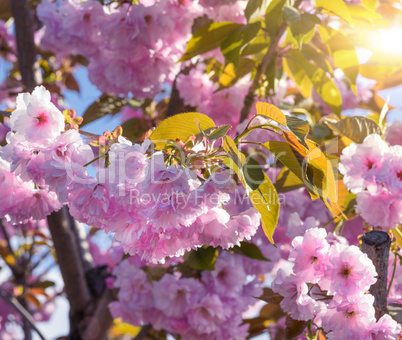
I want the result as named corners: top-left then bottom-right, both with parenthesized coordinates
top-left (326, 116), bottom-right (382, 144)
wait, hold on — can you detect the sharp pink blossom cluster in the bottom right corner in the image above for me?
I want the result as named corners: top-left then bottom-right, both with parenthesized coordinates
top-left (272, 228), bottom-right (401, 340)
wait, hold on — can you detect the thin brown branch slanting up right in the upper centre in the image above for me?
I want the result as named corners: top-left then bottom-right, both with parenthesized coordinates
top-left (240, 0), bottom-right (302, 123)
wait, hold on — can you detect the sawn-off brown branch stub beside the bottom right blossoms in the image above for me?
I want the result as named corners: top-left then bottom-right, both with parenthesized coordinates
top-left (362, 230), bottom-right (391, 320)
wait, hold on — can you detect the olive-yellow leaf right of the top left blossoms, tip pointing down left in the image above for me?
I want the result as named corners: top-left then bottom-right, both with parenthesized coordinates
top-left (179, 22), bottom-right (243, 61)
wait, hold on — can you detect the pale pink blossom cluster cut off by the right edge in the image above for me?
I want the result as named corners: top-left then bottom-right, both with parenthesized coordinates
top-left (339, 134), bottom-right (402, 229)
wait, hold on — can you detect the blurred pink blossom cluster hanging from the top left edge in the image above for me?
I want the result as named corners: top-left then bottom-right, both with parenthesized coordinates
top-left (37, 0), bottom-right (246, 99)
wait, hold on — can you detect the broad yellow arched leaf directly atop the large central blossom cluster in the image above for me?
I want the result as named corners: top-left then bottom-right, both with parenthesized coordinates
top-left (149, 112), bottom-right (215, 150)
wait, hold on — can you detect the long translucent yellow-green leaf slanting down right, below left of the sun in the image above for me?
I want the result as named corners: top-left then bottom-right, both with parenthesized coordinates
top-left (286, 50), bottom-right (342, 116)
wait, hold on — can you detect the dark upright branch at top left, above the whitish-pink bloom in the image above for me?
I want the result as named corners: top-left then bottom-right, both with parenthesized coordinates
top-left (11, 0), bottom-right (41, 90)
